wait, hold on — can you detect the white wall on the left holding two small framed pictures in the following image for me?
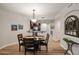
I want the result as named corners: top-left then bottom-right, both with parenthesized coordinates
top-left (0, 10), bottom-right (29, 47)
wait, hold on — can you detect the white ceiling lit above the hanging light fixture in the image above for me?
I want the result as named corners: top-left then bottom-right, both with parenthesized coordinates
top-left (0, 3), bottom-right (68, 20)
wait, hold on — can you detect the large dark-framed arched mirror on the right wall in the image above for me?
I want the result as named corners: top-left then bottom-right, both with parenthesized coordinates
top-left (64, 15), bottom-right (79, 37)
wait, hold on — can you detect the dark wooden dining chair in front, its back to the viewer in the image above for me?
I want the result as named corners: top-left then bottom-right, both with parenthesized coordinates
top-left (23, 38), bottom-right (37, 55)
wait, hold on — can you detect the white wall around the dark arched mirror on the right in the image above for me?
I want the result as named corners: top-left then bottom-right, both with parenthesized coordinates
top-left (56, 4), bottom-right (79, 54)
